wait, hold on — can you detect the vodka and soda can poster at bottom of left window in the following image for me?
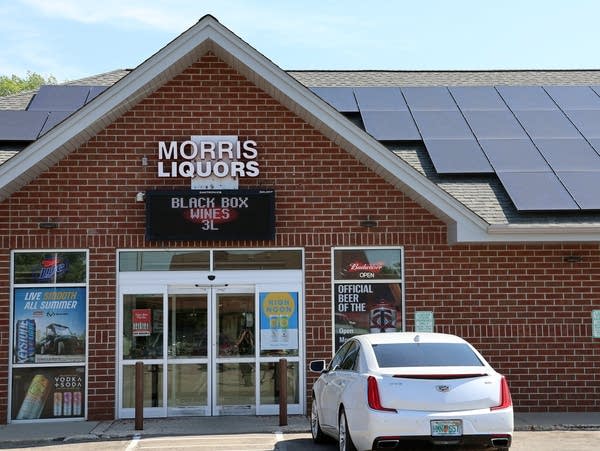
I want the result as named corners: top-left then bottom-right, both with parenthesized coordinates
top-left (11, 366), bottom-right (85, 420)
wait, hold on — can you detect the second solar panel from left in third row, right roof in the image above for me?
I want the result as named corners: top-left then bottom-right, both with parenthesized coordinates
top-left (479, 139), bottom-right (551, 172)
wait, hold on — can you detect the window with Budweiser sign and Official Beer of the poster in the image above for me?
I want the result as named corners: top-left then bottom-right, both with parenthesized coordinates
top-left (333, 248), bottom-right (405, 351)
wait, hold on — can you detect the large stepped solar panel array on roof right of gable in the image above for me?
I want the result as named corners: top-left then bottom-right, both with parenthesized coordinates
top-left (313, 86), bottom-right (600, 211)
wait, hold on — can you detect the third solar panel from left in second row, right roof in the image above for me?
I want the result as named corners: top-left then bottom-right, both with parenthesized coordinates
top-left (464, 110), bottom-right (527, 139)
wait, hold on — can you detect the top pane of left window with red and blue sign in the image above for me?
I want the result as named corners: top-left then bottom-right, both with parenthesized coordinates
top-left (13, 252), bottom-right (87, 285)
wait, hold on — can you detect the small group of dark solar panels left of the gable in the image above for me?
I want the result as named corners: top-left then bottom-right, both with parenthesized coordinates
top-left (0, 85), bottom-right (107, 141)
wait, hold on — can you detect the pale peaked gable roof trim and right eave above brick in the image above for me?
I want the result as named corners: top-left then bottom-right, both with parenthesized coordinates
top-left (0, 16), bottom-right (600, 242)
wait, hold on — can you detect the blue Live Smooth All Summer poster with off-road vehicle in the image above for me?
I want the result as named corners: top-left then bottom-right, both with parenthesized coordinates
top-left (13, 287), bottom-right (86, 364)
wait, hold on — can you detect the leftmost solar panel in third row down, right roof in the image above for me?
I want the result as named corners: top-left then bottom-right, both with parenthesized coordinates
top-left (424, 139), bottom-right (494, 174)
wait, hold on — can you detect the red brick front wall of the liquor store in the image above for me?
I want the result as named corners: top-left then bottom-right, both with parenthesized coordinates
top-left (0, 55), bottom-right (600, 420)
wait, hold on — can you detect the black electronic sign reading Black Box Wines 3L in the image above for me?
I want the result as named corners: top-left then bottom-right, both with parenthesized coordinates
top-left (146, 189), bottom-right (275, 241)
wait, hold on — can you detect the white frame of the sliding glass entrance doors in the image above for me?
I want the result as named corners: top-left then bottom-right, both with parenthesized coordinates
top-left (115, 262), bottom-right (306, 418)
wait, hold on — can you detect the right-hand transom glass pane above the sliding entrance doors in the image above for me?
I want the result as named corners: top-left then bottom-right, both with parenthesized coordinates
top-left (213, 249), bottom-right (302, 270)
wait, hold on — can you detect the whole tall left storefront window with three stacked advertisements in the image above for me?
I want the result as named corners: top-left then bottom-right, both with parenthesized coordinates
top-left (11, 251), bottom-right (88, 420)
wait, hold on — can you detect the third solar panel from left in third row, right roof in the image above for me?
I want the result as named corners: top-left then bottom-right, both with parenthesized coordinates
top-left (534, 138), bottom-right (600, 172)
